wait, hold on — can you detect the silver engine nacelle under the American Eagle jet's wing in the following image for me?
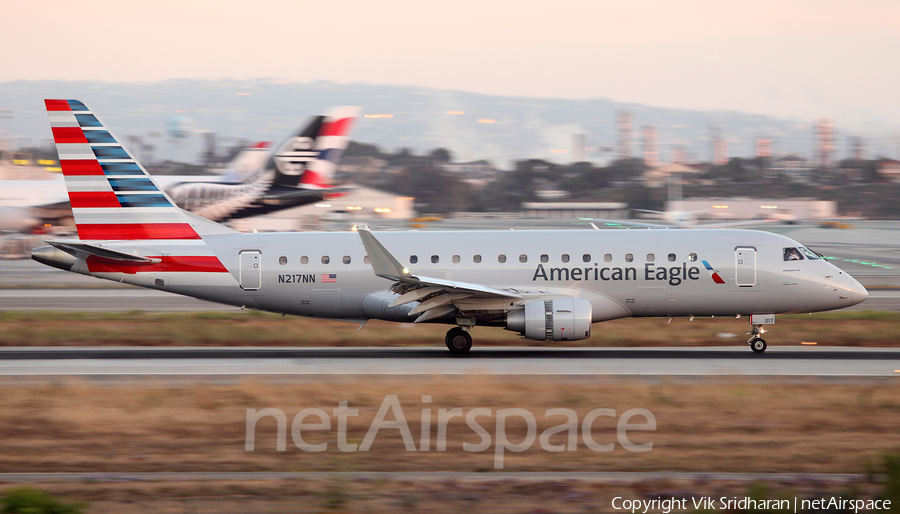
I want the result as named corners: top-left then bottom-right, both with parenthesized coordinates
top-left (506, 298), bottom-right (591, 341)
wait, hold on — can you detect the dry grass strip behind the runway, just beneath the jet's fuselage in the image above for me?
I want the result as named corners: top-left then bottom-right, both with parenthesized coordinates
top-left (0, 311), bottom-right (900, 351)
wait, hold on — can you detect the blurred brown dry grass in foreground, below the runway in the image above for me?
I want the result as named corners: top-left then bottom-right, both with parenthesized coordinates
top-left (0, 376), bottom-right (900, 513)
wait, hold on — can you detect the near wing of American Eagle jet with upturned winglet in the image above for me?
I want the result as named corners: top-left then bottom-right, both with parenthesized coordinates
top-left (357, 226), bottom-right (522, 323)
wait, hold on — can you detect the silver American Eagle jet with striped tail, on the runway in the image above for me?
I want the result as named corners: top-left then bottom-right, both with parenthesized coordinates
top-left (32, 100), bottom-right (868, 353)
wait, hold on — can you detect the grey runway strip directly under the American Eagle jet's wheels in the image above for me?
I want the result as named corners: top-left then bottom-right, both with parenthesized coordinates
top-left (0, 345), bottom-right (900, 379)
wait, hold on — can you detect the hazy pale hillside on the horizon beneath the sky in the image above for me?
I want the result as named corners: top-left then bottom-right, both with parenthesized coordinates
top-left (0, 79), bottom-right (900, 166)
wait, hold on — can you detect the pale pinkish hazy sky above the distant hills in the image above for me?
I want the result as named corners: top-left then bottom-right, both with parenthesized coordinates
top-left (0, 0), bottom-right (900, 134)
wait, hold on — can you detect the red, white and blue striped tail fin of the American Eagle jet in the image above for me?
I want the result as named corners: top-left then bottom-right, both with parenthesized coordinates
top-left (44, 100), bottom-right (234, 240)
